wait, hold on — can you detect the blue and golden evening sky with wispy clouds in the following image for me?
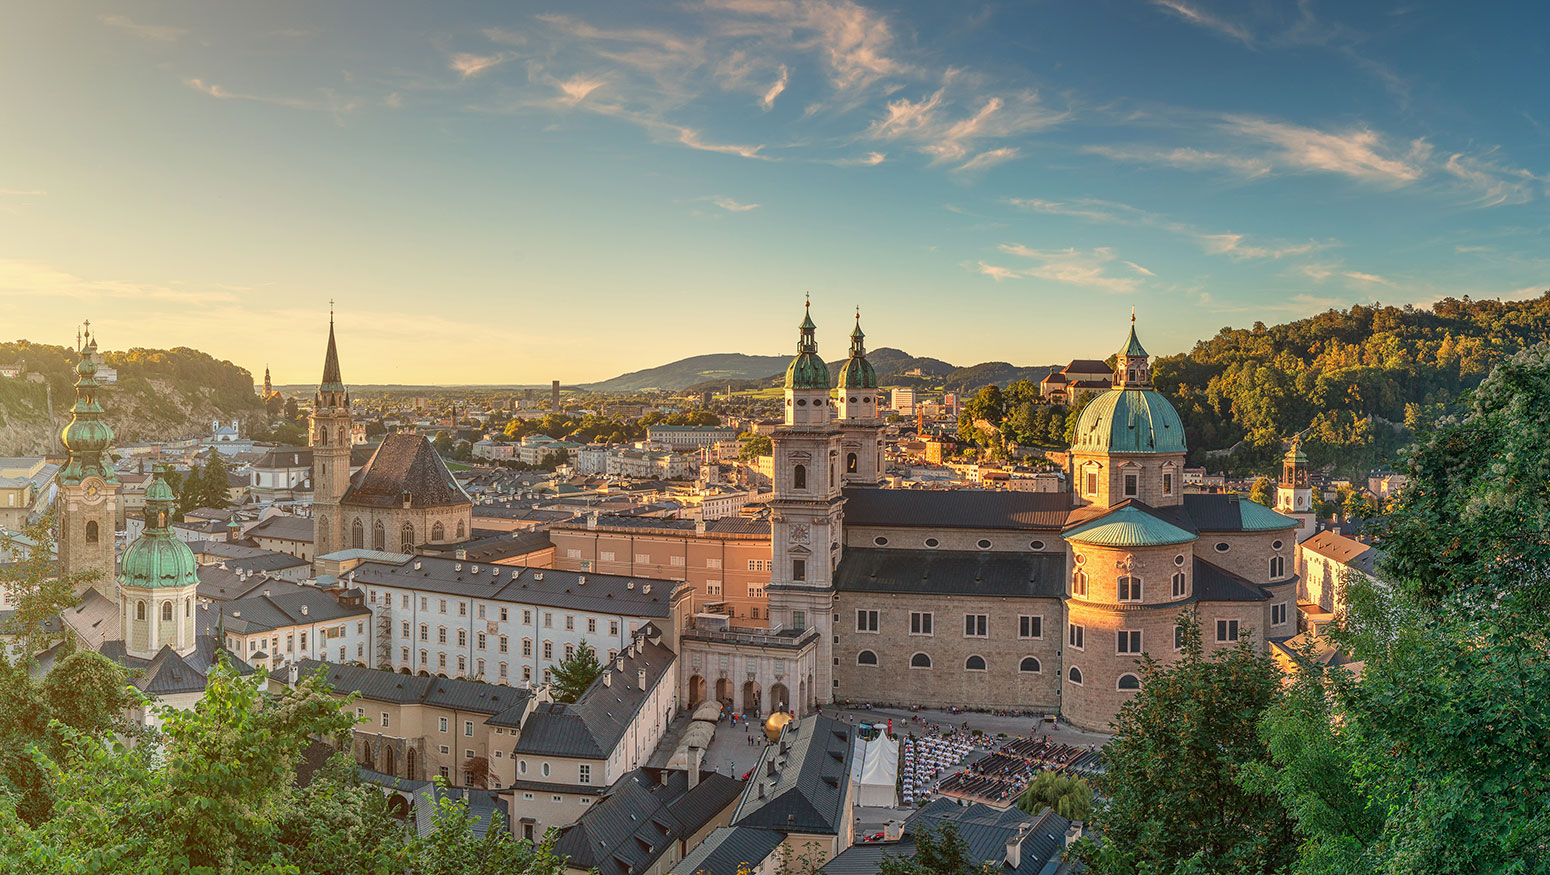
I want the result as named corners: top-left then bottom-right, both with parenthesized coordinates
top-left (0, 0), bottom-right (1550, 384)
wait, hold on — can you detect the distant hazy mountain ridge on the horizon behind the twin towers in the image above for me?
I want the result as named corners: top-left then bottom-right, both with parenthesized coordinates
top-left (581, 347), bottom-right (1057, 392)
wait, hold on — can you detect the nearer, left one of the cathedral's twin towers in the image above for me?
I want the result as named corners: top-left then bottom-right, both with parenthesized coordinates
top-left (766, 305), bottom-right (845, 705)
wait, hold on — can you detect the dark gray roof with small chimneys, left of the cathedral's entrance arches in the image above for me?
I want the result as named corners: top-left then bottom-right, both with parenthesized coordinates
top-left (516, 626), bottom-right (677, 759)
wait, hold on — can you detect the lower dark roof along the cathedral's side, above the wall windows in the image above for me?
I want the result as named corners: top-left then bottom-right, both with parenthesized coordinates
top-left (834, 545), bottom-right (1065, 598)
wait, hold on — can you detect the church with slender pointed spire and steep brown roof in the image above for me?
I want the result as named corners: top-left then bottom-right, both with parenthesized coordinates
top-left (308, 316), bottom-right (473, 556)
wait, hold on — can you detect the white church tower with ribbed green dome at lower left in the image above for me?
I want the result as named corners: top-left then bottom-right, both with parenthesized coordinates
top-left (118, 465), bottom-right (198, 660)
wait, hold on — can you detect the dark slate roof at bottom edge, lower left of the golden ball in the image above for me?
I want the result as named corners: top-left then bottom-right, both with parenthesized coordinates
top-left (555, 768), bottom-right (742, 875)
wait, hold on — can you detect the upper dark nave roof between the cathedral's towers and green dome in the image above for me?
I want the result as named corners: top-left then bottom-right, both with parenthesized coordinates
top-left (845, 486), bottom-right (1071, 531)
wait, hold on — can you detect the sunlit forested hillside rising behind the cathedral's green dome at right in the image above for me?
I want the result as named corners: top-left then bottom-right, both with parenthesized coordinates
top-left (1153, 293), bottom-right (1550, 472)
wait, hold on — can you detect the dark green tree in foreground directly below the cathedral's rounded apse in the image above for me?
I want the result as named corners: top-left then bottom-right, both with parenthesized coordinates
top-left (1079, 610), bottom-right (1297, 875)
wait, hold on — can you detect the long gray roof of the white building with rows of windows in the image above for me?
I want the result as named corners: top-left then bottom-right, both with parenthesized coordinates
top-left (349, 556), bottom-right (688, 618)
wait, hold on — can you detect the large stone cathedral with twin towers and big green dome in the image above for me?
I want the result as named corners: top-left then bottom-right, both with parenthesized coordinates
top-left (744, 306), bottom-right (1307, 729)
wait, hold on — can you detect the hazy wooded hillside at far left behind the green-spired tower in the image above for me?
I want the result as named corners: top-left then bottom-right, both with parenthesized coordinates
top-left (0, 341), bottom-right (262, 455)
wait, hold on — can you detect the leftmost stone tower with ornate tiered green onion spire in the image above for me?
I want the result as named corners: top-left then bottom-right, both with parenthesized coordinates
top-left (59, 322), bottom-right (119, 599)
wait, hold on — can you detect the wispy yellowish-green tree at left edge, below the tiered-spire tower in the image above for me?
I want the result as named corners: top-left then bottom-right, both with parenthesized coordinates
top-left (0, 510), bottom-right (87, 657)
